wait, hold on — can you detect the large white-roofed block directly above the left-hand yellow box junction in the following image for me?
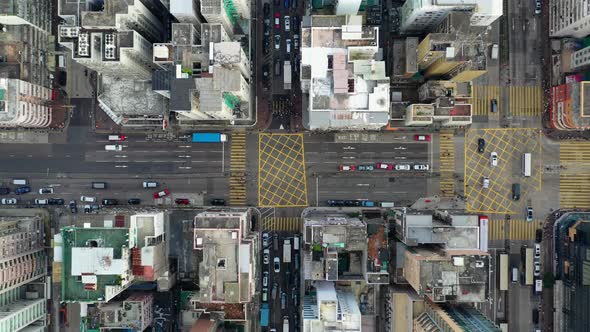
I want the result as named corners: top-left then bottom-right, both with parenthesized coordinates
top-left (300, 15), bottom-right (390, 130)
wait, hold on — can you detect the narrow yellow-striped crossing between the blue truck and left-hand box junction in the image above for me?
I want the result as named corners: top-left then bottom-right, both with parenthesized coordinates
top-left (229, 133), bottom-right (246, 206)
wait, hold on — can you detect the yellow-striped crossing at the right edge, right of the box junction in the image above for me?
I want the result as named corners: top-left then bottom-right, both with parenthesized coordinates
top-left (559, 142), bottom-right (590, 209)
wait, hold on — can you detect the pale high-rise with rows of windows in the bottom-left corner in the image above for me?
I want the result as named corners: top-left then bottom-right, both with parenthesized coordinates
top-left (0, 216), bottom-right (47, 332)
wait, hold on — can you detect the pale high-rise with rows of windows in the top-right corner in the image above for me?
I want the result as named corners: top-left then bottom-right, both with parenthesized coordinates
top-left (547, 0), bottom-right (590, 38)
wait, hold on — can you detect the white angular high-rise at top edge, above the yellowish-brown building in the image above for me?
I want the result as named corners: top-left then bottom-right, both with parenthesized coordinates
top-left (400, 0), bottom-right (502, 33)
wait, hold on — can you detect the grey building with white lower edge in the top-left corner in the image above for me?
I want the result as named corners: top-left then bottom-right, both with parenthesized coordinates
top-left (0, 0), bottom-right (52, 33)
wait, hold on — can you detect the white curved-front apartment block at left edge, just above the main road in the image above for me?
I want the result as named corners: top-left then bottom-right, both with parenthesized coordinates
top-left (0, 78), bottom-right (53, 128)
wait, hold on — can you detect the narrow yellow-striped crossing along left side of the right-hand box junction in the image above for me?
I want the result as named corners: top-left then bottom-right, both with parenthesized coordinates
top-left (439, 129), bottom-right (455, 197)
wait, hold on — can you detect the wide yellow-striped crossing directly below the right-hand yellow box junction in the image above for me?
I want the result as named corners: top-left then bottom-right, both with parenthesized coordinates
top-left (488, 219), bottom-right (543, 241)
